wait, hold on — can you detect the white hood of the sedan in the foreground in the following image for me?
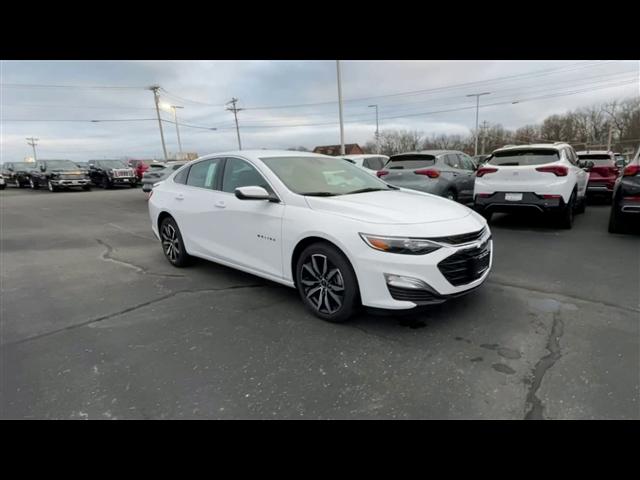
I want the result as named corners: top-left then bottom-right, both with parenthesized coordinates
top-left (305, 190), bottom-right (472, 225)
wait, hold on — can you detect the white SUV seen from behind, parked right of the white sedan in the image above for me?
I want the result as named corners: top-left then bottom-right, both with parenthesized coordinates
top-left (473, 143), bottom-right (593, 228)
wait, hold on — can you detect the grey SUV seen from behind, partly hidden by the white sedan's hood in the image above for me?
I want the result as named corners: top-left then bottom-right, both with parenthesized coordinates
top-left (377, 150), bottom-right (476, 203)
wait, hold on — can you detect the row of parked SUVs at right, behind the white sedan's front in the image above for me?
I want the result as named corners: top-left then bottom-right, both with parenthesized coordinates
top-left (377, 142), bottom-right (640, 232)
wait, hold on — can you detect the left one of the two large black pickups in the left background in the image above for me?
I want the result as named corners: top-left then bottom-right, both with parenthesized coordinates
top-left (29, 160), bottom-right (91, 192)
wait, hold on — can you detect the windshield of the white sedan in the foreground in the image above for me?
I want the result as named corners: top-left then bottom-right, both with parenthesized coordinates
top-left (261, 157), bottom-right (392, 196)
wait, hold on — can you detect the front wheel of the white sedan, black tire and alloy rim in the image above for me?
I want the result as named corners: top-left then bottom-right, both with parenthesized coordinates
top-left (296, 242), bottom-right (360, 323)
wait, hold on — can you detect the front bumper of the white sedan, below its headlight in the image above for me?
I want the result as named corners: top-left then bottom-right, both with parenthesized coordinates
top-left (354, 228), bottom-right (493, 310)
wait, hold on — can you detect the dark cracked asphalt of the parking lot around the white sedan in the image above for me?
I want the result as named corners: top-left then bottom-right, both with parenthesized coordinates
top-left (0, 188), bottom-right (640, 419)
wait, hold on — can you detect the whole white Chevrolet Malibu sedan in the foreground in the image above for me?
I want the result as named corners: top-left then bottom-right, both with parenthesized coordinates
top-left (149, 150), bottom-right (493, 322)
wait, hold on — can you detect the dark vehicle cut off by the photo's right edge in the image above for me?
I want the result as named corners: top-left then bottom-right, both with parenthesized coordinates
top-left (609, 149), bottom-right (640, 233)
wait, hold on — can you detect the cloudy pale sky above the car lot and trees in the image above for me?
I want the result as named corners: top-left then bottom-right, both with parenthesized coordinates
top-left (0, 60), bottom-right (640, 161)
